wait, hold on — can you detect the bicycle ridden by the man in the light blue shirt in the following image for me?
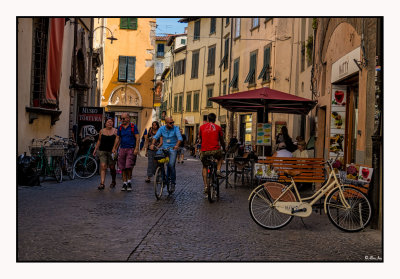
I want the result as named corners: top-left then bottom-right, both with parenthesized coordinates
top-left (154, 148), bottom-right (174, 200)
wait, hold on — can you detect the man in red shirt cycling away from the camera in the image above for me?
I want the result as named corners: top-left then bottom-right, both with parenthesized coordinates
top-left (199, 113), bottom-right (225, 193)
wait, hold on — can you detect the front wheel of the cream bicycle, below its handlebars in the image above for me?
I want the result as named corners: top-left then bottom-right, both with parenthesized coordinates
top-left (326, 186), bottom-right (372, 232)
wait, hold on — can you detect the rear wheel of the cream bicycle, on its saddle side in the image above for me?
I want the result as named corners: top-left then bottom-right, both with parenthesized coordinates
top-left (249, 182), bottom-right (296, 230)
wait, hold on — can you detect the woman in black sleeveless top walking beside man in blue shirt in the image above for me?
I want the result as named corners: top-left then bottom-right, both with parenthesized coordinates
top-left (93, 118), bottom-right (117, 190)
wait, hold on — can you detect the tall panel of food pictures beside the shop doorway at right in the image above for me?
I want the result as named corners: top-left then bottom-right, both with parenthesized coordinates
top-left (329, 85), bottom-right (347, 161)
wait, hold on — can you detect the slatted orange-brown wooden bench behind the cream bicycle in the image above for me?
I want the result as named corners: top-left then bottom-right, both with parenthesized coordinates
top-left (258, 157), bottom-right (326, 183)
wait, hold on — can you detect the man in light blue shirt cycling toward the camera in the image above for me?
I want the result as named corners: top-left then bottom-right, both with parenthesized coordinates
top-left (150, 117), bottom-right (182, 191)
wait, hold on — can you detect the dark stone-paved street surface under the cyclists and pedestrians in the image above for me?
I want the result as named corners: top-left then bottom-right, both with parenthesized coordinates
top-left (17, 152), bottom-right (383, 262)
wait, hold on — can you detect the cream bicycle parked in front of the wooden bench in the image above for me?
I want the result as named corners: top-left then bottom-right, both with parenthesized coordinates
top-left (249, 156), bottom-right (372, 232)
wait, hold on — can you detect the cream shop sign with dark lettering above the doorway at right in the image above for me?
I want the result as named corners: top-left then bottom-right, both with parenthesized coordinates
top-left (331, 47), bottom-right (361, 83)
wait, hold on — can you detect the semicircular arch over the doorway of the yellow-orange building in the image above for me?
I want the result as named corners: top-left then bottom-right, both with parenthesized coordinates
top-left (108, 85), bottom-right (142, 107)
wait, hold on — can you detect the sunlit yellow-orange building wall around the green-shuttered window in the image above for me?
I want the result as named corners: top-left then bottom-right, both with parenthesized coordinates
top-left (101, 18), bottom-right (156, 133)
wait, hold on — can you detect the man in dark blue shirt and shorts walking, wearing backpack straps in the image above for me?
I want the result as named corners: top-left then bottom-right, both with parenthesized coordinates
top-left (112, 113), bottom-right (140, 191)
